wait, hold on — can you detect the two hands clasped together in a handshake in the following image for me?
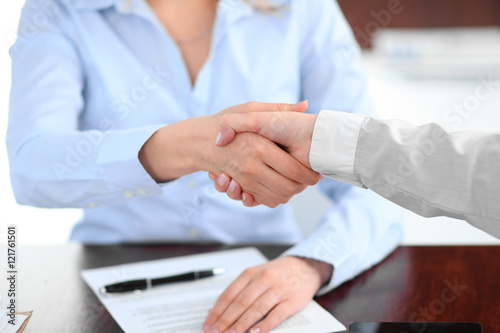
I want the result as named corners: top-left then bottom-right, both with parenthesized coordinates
top-left (209, 101), bottom-right (323, 208)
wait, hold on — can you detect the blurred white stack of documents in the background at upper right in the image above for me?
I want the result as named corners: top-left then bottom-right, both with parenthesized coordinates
top-left (373, 27), bottom-right (500, 79)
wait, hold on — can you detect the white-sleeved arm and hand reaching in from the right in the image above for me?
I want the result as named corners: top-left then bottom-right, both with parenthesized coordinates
top-left (212, 110), bottom-right (500, 238)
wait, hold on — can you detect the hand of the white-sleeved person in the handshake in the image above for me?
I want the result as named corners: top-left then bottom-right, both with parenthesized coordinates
top-left (209, 112), bottom-right (317, 207)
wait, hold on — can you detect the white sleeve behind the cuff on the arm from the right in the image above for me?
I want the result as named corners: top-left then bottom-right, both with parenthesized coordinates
top-left (355, 119), bottom-right (500, 237)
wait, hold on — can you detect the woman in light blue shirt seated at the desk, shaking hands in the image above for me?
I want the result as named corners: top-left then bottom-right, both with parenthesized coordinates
top-left (7, 0), bottom-right (402, 333)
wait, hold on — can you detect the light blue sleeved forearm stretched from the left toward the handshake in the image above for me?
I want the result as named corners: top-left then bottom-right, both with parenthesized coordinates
top-left (7, 125), bottom-right (162, 208)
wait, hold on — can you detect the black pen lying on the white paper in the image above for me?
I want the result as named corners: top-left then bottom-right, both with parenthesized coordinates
top-left (99, 268), bottom-right (225, 294)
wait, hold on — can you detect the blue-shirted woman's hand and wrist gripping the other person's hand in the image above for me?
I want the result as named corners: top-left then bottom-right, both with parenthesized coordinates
top-left (139, 102), bottom-right (320, 207)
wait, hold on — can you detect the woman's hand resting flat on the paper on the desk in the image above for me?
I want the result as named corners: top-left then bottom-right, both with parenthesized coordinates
top-left (203, 257), bottom-right (332, 333)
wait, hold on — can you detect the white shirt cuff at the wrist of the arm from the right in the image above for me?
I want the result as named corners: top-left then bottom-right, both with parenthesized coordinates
top-left (309, 110), bottom-right (368, 187)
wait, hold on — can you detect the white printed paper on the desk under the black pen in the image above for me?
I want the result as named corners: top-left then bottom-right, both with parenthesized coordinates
top-left (82, 248), bottom-right (345, 333)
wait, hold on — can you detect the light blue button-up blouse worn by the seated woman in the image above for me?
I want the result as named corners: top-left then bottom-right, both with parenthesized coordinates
top-left (7, 0), bottom-right (402, 290)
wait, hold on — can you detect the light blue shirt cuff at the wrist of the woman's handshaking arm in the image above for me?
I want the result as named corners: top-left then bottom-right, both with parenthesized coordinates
top-left (97, 125), bottom-right (164, 202)
